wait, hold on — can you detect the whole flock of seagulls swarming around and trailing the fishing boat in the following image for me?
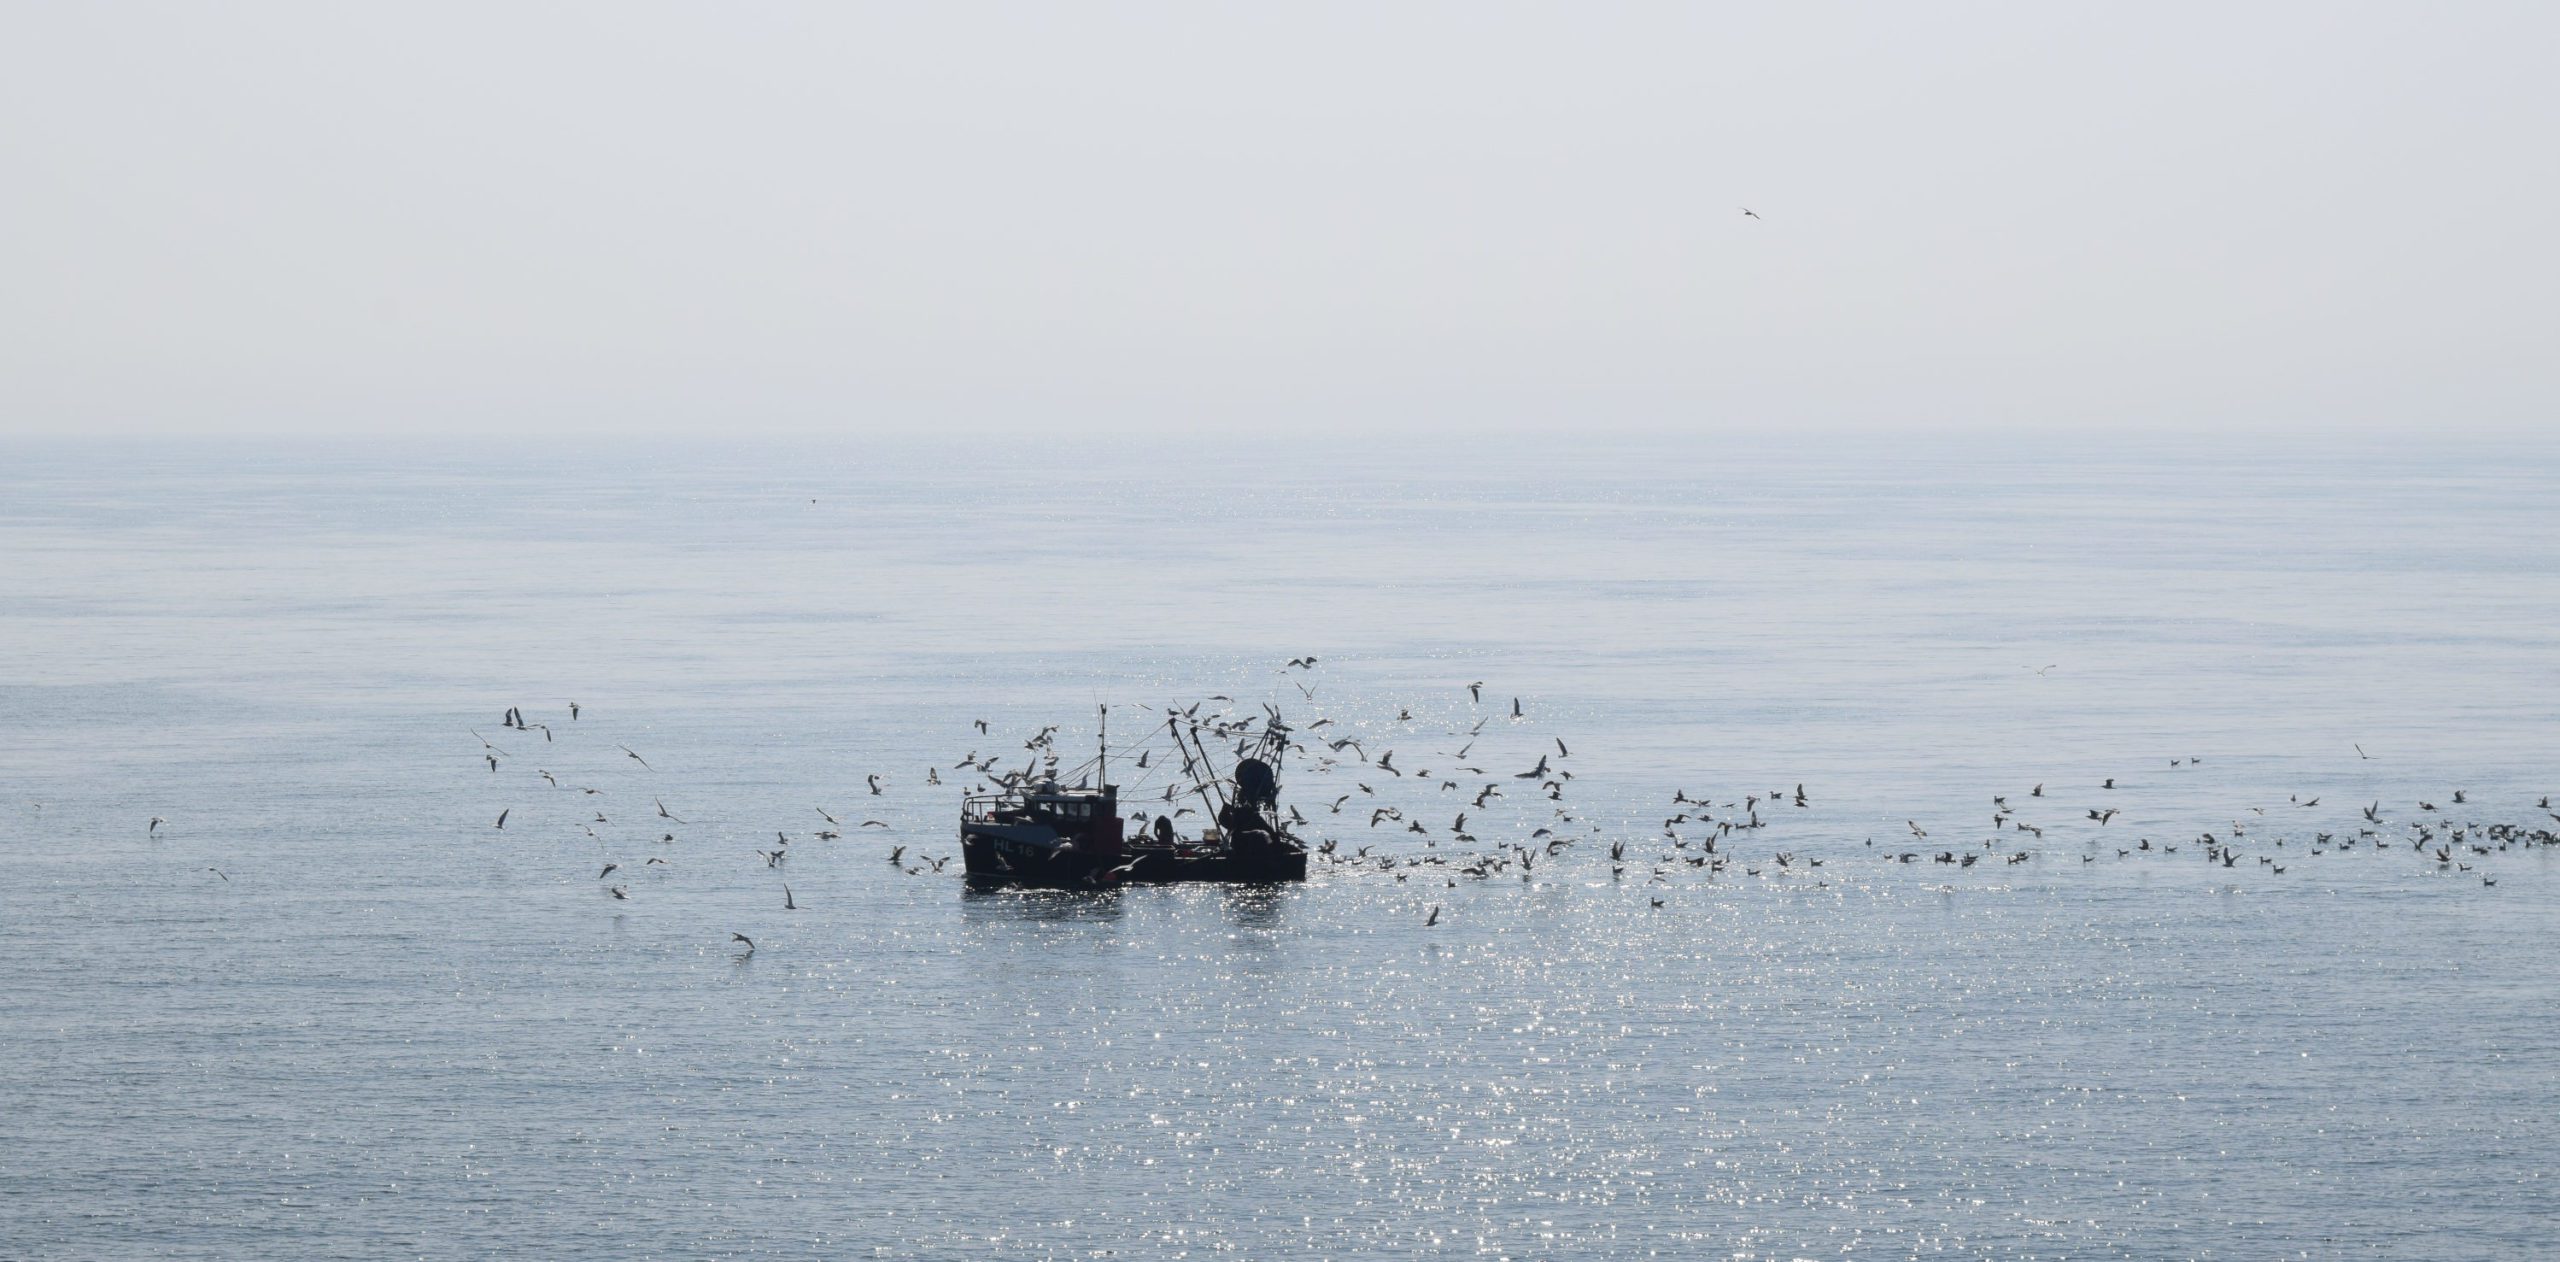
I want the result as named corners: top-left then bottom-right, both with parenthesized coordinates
top-left (146, 655), bottom-right (2529, 952)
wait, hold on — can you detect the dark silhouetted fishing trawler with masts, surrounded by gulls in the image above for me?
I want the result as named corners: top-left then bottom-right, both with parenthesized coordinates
top-left (960, 709), bottom-right (1306, 888)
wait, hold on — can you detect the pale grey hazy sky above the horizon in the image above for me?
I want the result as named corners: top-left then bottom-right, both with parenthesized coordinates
top-left (0, 0), bottom-right (2560, 435)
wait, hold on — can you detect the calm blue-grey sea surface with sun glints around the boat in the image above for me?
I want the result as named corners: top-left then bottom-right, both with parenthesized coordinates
top-left (0, 438), bottom-right (2560, 1259)
